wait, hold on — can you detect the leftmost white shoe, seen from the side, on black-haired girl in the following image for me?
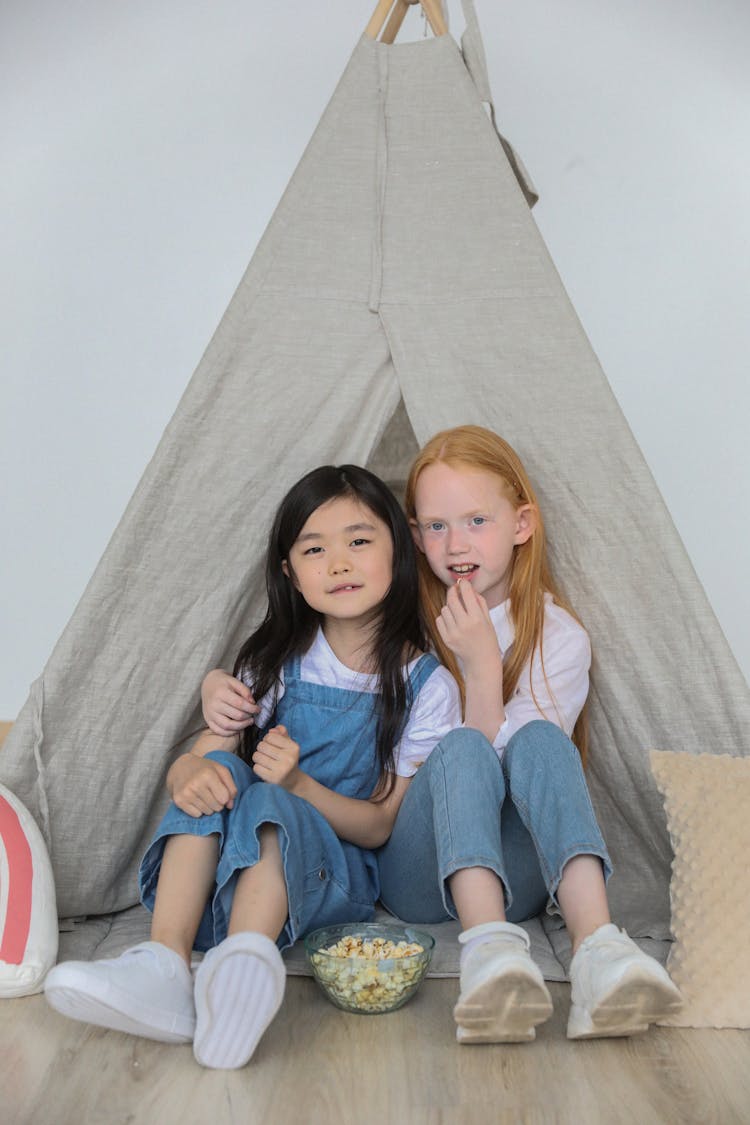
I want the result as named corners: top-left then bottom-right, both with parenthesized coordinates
top-left (44, 942), bottom-right (196, 1043)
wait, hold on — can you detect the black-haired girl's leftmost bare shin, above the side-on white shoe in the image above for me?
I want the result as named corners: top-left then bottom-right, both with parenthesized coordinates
top-left (151, 835), bottom-right (218, 965)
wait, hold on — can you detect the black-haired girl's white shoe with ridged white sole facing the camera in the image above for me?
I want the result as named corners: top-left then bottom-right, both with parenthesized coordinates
top-left (192, 933), bottom-right (287, 1070)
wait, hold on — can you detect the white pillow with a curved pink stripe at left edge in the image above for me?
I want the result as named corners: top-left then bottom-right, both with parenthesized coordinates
top-left (0, 785), bottom-right (57, 997)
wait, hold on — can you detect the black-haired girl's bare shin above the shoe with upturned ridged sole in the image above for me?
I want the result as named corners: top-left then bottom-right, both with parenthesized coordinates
top-left (229, 825), bottom-right (289, 942)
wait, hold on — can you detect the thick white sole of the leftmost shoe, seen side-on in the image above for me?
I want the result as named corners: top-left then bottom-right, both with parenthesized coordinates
top-left (44, 965), bottom-right (196, 1043)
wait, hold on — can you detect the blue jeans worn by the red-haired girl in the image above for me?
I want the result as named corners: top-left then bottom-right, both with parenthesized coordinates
top-left (377, 720), bottom-right (612, 923)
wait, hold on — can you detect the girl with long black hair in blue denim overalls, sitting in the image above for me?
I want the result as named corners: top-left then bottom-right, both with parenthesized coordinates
top-left (45, 465), bottom-right (460, 1069)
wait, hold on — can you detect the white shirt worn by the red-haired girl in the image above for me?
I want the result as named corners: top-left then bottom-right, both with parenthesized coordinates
top-left (481, 594), bottom-right (591, 757)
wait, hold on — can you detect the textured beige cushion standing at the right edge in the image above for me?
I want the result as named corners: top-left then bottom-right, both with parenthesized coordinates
top-left (651, 750), bottom-right (750, 1027)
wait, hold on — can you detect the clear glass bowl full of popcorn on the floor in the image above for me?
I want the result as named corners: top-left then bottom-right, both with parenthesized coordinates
top-left (305, 923), bottom-right (435, 1015)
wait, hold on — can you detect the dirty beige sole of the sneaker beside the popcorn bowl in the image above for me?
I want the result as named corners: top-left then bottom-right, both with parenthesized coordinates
top-left (453, 970), bottom-right (552, 1044)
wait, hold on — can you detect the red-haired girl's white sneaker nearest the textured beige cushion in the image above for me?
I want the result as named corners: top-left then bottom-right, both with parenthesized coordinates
top-left (568, 923), bottom-right (683, 1040)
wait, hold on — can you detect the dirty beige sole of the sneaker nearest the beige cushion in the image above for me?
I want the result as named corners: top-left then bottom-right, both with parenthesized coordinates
top-left (568, 966), bottom-right (683, 1040)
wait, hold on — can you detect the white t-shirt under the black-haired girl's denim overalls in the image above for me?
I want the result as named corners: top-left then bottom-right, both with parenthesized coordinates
top-left (249, 629), bottom-right (461, 777)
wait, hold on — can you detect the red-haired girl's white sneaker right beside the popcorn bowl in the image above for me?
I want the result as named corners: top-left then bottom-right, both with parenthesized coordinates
top-left (453, 921), bottom-right (552, 1043)
